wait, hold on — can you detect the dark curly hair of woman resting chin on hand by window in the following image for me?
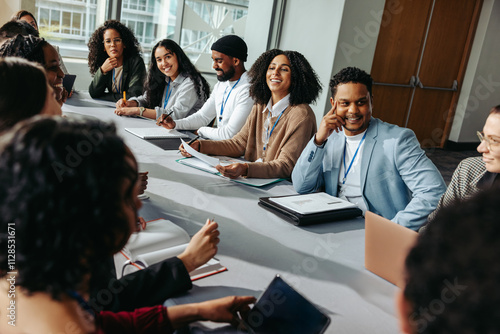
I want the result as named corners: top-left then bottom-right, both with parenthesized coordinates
top-left (87, 20), bottom-right (141, 75)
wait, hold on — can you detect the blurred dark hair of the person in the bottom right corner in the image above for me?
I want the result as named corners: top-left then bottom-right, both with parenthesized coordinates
top-left (404, 187), bottom-right (500, 333)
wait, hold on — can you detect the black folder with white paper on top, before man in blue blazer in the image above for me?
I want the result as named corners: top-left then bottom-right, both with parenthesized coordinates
top-left (259, 193), bottom-right (363, 226)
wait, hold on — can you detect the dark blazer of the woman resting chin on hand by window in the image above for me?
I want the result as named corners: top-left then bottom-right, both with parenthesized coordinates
top-left (89, 56), bottom-right (146, 101)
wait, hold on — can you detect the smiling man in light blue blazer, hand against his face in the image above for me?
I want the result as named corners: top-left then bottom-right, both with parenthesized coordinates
top-left (292, 67), bottom-right (446, 230)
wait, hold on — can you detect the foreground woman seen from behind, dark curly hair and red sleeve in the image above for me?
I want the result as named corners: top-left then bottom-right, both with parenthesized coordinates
top-left (0, 116), bottom-right (255, 333)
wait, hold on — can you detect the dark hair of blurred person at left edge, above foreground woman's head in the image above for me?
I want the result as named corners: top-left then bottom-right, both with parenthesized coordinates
top-left (0, 57), bottom-right (47, 133)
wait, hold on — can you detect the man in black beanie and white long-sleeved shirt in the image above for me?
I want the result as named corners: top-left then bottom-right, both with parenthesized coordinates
top-left (157, 35), bottom-right (253, 140)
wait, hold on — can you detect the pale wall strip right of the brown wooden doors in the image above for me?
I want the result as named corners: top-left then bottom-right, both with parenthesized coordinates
top-left (449, 0), bottom-right (500, 143)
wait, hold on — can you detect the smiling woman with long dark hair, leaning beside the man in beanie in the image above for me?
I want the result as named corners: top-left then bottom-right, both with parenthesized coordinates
top-left (115, 39), bottom-right (210, 120)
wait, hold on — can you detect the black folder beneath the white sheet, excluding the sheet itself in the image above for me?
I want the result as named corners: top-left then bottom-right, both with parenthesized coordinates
top-left (259, 195), bottom-right (363, 226)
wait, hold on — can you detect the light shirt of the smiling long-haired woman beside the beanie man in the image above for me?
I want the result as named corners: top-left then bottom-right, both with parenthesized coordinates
top-left (130, 74), bottom-right (205, 120)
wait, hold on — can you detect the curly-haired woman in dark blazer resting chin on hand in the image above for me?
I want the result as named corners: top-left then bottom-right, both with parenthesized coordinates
top-left (88, 20), bottom-right (146, 101)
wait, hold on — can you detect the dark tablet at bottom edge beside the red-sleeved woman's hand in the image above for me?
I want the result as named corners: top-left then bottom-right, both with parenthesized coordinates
top-left (243, 275), bottom-right (330, 334)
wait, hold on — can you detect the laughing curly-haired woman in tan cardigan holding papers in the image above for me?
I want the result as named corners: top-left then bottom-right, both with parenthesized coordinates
top-left (180, 49), bottom-right (321, 178)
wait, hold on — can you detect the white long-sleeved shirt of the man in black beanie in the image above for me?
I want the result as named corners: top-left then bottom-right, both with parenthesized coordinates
top-left (175, 72), bottom-right (254, 140)
